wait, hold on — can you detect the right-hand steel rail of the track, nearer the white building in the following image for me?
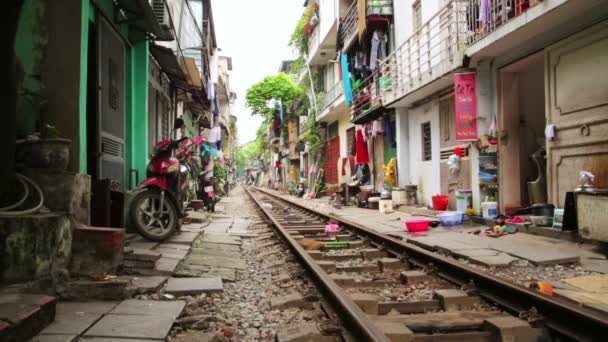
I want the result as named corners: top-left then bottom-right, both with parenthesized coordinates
top-left (257, 188), bottom-right (608, 341)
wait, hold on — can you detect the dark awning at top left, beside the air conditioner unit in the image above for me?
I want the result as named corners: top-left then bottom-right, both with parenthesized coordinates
top-left (117, 0), bottom-right (175, 41)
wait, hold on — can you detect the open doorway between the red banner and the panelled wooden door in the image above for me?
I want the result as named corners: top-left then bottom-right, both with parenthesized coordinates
top-left (497, 52), bottom-right (547, 212)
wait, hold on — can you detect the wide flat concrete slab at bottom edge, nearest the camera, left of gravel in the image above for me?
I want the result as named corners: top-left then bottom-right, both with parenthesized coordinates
top-left (84, 315), bottom-right (174, 341)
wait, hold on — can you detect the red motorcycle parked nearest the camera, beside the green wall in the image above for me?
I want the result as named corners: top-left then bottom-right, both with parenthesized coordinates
top-left (130, 119), bottom-right (190, 242)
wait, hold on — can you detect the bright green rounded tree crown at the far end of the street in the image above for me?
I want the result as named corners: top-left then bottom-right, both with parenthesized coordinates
top-left (245, 72), bottom-right (303, 123)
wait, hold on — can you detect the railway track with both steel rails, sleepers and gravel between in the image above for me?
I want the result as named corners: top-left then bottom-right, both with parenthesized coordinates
top-left (246, 188), bottom-right (608, 341)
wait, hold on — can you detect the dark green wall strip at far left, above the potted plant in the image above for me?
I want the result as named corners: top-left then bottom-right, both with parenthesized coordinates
top-left (15, 0), bottom-right (49, 136)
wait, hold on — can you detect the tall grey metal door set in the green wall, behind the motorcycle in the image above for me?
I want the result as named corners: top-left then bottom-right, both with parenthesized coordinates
top-left (97, 16), bottom-right (125, 190)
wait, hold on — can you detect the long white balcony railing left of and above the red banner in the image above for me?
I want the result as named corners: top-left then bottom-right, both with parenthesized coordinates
top-left (378, 0), bottom-right (470, 104)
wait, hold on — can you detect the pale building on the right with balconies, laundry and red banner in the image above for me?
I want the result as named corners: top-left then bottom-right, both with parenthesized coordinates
top-left (300, 0), bottom-right (608, 212)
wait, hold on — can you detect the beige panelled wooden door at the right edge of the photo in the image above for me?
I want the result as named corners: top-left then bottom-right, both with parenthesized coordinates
top-left (545, 21), bottom-right (608, 207)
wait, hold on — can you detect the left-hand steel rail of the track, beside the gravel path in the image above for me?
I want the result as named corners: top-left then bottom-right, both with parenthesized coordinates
top-left (244, 187), bottom-right (390, 342)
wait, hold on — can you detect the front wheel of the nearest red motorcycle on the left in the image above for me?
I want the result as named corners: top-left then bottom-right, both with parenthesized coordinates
top-left (131, 189), bottom-right (179, 242)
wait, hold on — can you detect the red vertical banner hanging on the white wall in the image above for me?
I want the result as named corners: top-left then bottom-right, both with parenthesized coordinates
top-left (454, 72), bottom-right (477, 141)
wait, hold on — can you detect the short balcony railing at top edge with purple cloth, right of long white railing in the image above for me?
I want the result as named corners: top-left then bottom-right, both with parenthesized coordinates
top-left (467, 0), bottom-right (542, 45)
